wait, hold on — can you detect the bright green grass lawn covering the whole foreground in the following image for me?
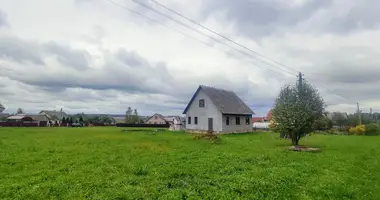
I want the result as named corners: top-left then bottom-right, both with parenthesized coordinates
top-left (0, 127), bottom-right (380, 200)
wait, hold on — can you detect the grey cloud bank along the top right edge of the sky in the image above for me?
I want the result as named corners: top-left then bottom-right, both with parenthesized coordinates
top-left (204, 0), bottom-right (380, 38)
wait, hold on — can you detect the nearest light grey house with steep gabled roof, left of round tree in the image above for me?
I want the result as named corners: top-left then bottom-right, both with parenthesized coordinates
top-left (183, 85), bottom-right (254, 133)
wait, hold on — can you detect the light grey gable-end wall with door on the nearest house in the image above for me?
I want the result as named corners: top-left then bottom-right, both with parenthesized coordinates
top-left (186, 90), bottom-right (223, 132)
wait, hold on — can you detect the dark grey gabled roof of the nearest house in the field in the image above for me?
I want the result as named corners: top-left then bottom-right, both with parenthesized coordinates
top-left (183, 85), bottom-right (255, 115)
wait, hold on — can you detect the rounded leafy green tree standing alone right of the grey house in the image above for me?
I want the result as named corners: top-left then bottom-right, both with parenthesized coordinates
top-left (272, 78), bottom-right (325, 145)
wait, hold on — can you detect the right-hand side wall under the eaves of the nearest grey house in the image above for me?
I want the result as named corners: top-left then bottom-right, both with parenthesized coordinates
top-left (223, 115), bottom-right (252, 133)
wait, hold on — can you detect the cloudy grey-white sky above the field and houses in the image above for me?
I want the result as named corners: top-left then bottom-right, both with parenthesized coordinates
top-left (0, 0), bottom-right (380, 116)
